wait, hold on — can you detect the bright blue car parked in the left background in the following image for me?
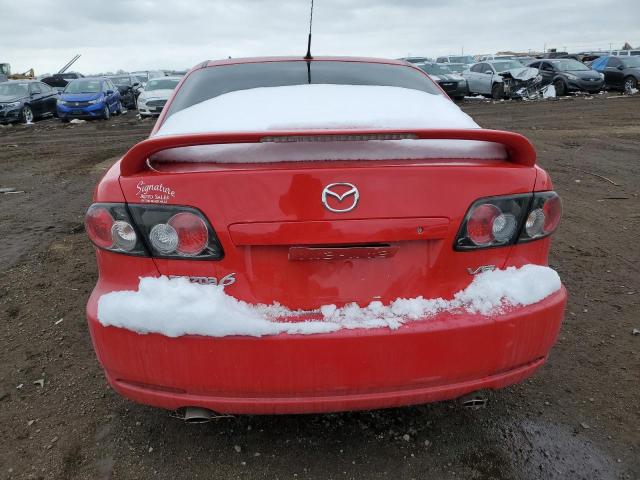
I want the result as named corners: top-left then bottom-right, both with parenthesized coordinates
top-left (57, 78), bottom-right (122, 122)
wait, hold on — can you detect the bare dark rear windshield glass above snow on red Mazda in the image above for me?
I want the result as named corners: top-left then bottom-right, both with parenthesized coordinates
top-left (167, 61), bottom-right (442, 117)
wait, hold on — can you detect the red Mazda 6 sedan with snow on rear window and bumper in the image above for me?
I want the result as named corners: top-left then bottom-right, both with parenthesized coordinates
top-left (86, 57), bottom-right (567, 414)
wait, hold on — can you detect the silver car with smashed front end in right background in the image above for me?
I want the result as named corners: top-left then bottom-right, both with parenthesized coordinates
top-left (462, 60), bottom-right (546, 100)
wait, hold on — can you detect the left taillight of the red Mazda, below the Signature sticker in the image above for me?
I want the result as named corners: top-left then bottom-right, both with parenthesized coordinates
top-left (85, 203), bottom-right (223, 260)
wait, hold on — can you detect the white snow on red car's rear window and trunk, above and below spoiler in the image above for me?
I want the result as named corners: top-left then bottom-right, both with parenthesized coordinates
top-left (152, 85), bottom-right (506, 163)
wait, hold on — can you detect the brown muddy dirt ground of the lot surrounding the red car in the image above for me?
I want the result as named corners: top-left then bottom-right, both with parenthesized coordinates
top-left (0, 95), bottom-right (640, 479)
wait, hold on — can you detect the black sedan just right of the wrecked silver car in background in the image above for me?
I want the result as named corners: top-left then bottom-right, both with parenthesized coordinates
top-left (529, 58), bottom-right (604, 96)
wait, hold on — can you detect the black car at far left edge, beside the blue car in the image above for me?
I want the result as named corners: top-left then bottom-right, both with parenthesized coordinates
top-left (0, 80), bottom-right (58, 123)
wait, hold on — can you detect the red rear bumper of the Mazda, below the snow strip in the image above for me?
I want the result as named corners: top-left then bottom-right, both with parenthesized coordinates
top-left (87, 287), bottom-right (567, 414)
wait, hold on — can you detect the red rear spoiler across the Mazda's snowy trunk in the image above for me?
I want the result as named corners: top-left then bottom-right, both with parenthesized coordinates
top-left (120, 128), bottom-right (536, 177)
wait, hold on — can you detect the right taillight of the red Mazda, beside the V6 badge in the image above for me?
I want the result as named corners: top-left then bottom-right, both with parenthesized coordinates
top-left (454, 192), bottom-right (562, 250)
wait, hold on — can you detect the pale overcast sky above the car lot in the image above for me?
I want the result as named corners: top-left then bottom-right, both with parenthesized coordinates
top-left (0, 0), bottom-right (640, 74)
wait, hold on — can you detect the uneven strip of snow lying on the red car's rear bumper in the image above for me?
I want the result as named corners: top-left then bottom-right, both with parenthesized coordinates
top-left (98, 265), bottom-right (561, 337)
